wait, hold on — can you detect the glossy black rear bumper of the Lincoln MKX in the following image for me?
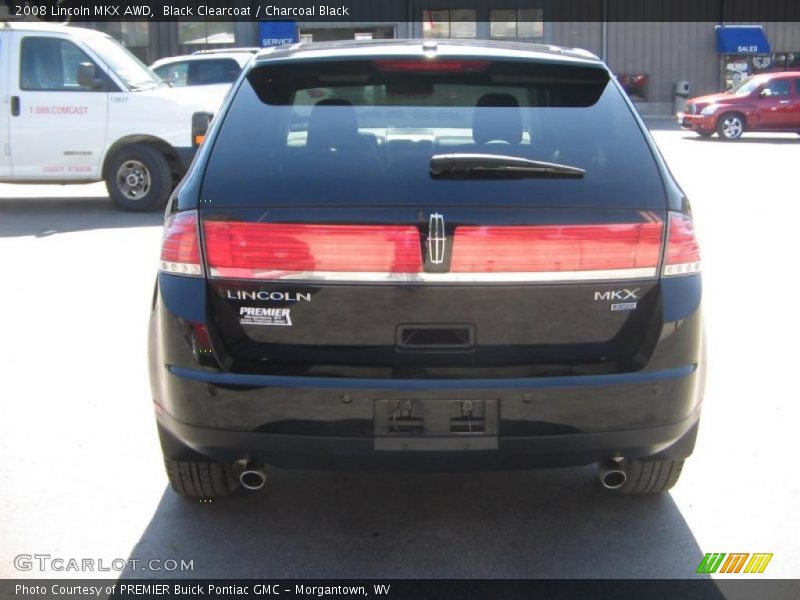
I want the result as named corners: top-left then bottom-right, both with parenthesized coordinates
top-left (156, 365), bottom-right (702, 469)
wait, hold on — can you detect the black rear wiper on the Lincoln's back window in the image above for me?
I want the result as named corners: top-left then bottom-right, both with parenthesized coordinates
top-left (429, 153), bottom-right (586, 179)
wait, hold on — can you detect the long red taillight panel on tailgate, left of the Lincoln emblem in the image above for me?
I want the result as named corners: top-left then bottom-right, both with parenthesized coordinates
top-left (203, 221), bottom-right (422, 278)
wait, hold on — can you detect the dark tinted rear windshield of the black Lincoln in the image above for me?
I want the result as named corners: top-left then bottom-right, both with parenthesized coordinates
top-left (202, 59), bottom-right (666, 208)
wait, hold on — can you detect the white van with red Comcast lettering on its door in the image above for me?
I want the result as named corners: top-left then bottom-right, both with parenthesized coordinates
top-left (0, 22), bottom-right (230, 211)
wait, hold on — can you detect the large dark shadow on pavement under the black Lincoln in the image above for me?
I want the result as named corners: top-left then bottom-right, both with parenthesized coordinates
top-left (122, 468), bottom-right (716, 589)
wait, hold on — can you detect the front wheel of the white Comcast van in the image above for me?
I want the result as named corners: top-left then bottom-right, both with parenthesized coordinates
top-left (106, 144), bottom-right (172, 212)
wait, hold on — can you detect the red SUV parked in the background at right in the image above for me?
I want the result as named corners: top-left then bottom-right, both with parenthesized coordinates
top-left (678, 71), bottom-right (800, 140)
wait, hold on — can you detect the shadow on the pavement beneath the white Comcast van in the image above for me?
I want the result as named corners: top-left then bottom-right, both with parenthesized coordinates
top-left (0, 197), bottom-right (164, 237)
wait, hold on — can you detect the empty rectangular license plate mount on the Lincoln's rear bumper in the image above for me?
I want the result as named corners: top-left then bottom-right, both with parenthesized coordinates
top-left (374, 399), bottom-right (499, 451)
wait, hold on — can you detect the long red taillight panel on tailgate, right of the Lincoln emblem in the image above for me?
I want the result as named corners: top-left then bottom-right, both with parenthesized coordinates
top-left (451, 221), bottom-right (662, 277)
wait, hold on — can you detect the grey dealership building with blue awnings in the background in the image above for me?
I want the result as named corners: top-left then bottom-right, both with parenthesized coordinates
top-left (78, 0), bottom-right (800, 115)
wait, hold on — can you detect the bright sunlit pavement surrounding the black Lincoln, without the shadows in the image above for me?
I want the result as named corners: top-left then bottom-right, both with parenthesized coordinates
top-left (0, 121), bottom-right (800, 578)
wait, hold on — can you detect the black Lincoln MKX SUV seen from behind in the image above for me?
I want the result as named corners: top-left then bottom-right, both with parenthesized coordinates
top-left (150, 41), bottom-right (704, 497)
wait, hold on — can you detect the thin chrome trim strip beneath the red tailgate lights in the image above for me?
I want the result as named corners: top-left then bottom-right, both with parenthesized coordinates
top-left (209, 267), bottom-right (658, 283)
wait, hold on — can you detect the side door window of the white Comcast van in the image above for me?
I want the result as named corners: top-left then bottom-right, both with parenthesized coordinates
top-left (19, 37), bottom-right (102, 92)
